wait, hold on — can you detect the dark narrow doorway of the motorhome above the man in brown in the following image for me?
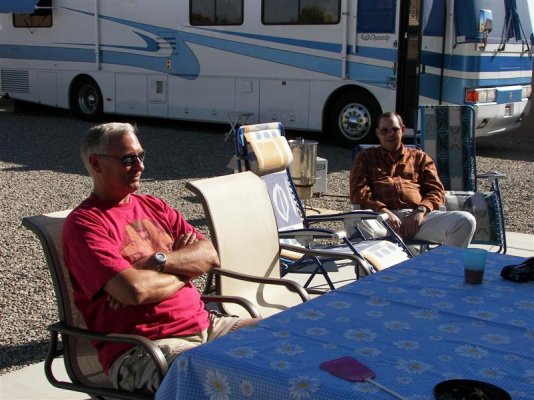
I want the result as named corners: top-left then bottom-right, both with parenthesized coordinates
top-left (395, 0), bottom-right (422, 128)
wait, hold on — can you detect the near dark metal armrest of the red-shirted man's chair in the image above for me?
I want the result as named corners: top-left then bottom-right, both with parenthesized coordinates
top-left (48, 322), bottom-right (169, 379)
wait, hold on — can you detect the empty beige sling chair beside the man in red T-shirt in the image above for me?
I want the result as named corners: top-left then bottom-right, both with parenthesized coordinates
top-left (186, 172), bottom-right (354, 317)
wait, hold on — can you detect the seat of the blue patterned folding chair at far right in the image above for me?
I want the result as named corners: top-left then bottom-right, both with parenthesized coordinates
top-left (445, 191), bottom-right (503, 245)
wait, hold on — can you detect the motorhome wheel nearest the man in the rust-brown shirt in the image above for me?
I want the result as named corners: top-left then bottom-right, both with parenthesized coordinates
top-left (327, 92), bottom-right (381, 147)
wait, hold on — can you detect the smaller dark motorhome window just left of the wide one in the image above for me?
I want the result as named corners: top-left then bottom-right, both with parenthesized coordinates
top-left (189, 0), bottom-right (243, 25)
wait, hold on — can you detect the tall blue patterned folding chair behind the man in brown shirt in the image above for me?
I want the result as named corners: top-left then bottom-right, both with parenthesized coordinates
top-left (415, 106), bottom-right (506, 253)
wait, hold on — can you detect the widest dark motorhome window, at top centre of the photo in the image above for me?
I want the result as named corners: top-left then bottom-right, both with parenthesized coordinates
top-left (262, 0), bottom-right (340, 25)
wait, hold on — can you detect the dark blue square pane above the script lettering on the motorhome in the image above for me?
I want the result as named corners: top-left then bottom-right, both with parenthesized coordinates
top-left (357, 0), bottom-right (397, 33)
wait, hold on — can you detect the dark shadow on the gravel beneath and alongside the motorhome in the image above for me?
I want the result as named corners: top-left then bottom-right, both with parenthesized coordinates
top-left (0, 102), bottom-right (358, 180)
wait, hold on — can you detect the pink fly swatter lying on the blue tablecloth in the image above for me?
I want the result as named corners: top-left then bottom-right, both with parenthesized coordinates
top-left (320, 357), bottom-right (405, 400)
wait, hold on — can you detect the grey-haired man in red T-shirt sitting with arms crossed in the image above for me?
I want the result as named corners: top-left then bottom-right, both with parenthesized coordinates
top-left (63, 123), bottom-right (256, 392)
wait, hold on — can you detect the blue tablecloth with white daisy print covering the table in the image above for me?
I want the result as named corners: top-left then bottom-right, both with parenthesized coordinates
top-left (156, 246), bottom-right (534, 400)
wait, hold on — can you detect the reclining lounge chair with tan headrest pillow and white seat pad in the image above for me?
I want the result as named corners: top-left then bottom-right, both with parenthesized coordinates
top-left (232, 122), bottom-right (412, 289)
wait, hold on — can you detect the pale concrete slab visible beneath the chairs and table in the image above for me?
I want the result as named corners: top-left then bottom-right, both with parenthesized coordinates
top-left (0, 232), bottom-right (534, 400)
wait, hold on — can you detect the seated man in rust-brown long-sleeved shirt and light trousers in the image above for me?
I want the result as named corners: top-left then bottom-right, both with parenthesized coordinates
top-left (350, 112), bottom-right (476, 247)
